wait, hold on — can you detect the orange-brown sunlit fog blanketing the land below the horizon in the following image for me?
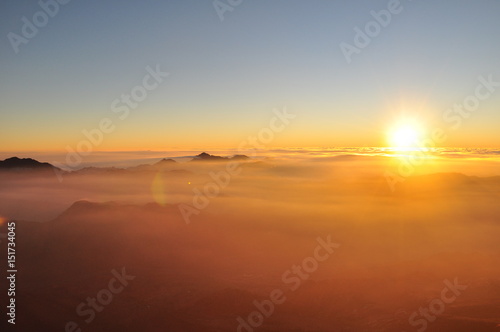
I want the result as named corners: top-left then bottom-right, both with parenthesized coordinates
top-left (0, 151), bottom-right (500, 331)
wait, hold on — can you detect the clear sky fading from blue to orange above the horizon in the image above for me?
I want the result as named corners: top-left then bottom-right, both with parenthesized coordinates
top-left (0, 0), bottom-right (500, 151)
